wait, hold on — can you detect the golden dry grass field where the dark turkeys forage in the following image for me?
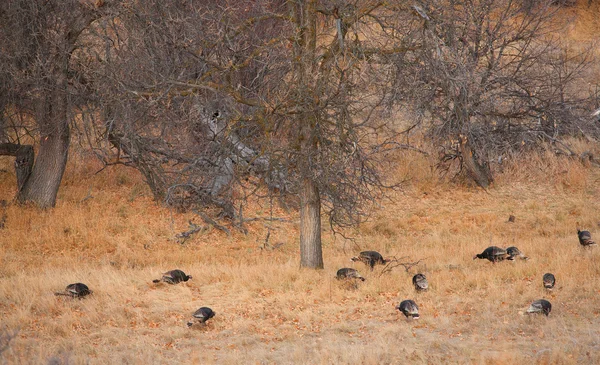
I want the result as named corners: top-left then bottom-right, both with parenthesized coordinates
top-left (0, 143), bottom-right (600, 364)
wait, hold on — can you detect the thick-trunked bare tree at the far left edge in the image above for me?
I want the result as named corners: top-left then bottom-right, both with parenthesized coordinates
top-left (0, 0), bottom-right (102, 208)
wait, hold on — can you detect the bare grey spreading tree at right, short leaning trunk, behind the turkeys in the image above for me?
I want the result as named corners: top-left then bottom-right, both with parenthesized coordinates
top-left (397, 0), bottom-right (598, 187)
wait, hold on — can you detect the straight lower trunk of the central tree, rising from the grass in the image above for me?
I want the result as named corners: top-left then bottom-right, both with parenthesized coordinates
top-left (300, 178), bottom-right (323, 269)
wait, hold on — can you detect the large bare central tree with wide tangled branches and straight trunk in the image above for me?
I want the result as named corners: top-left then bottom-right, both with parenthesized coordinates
top-left (88, 0), bottom-right (408, 268)
